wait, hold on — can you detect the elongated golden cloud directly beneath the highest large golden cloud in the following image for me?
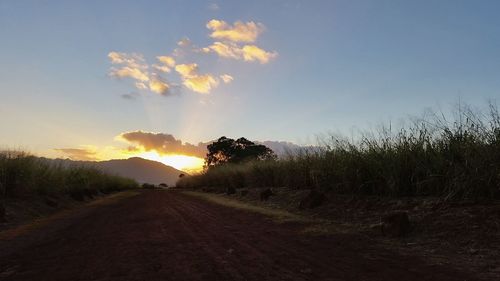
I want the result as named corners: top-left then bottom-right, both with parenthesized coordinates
top-left (202, 42), bottom-right (278, 64)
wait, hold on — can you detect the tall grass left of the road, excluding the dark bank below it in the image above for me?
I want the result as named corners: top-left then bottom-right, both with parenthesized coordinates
top-left (0, 151), bottom-right (138, 200)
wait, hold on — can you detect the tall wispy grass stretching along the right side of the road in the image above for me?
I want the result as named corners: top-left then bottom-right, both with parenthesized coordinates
top-left (177, 104), bottom-right (500, 199)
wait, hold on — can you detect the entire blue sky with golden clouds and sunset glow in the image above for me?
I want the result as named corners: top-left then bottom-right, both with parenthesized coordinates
top-left (0, 0), bottom-right (500, 170)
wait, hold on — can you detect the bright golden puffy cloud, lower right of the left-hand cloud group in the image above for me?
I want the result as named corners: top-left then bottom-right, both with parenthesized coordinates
top-left (175, 63), bottom-right (219, 94)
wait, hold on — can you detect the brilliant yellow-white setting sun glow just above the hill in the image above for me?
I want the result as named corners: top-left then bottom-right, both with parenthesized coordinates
top-left (137, 151), bottom-right (205, 173)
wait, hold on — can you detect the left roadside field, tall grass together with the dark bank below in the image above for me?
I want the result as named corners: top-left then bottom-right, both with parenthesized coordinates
top-left (0, 151), bottom-right (138, 225)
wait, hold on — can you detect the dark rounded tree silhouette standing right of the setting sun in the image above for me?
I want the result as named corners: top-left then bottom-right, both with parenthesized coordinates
top-left (205, 137), bottom-right (276, 168)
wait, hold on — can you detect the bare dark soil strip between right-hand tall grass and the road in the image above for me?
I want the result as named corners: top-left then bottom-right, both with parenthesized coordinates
top-left (231, 188), bottom-right (500, 280)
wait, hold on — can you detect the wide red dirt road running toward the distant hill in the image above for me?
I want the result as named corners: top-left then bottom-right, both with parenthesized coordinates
top-left (0, 191), bottom-right (484, 281)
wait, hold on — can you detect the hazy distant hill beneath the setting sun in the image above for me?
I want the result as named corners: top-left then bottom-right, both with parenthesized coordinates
top-left (44, 157), bottom-right (186, 186)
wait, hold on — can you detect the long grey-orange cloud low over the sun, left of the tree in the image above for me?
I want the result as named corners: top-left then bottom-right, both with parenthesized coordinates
top-left (117, 131), bottom-right (208, 158)
